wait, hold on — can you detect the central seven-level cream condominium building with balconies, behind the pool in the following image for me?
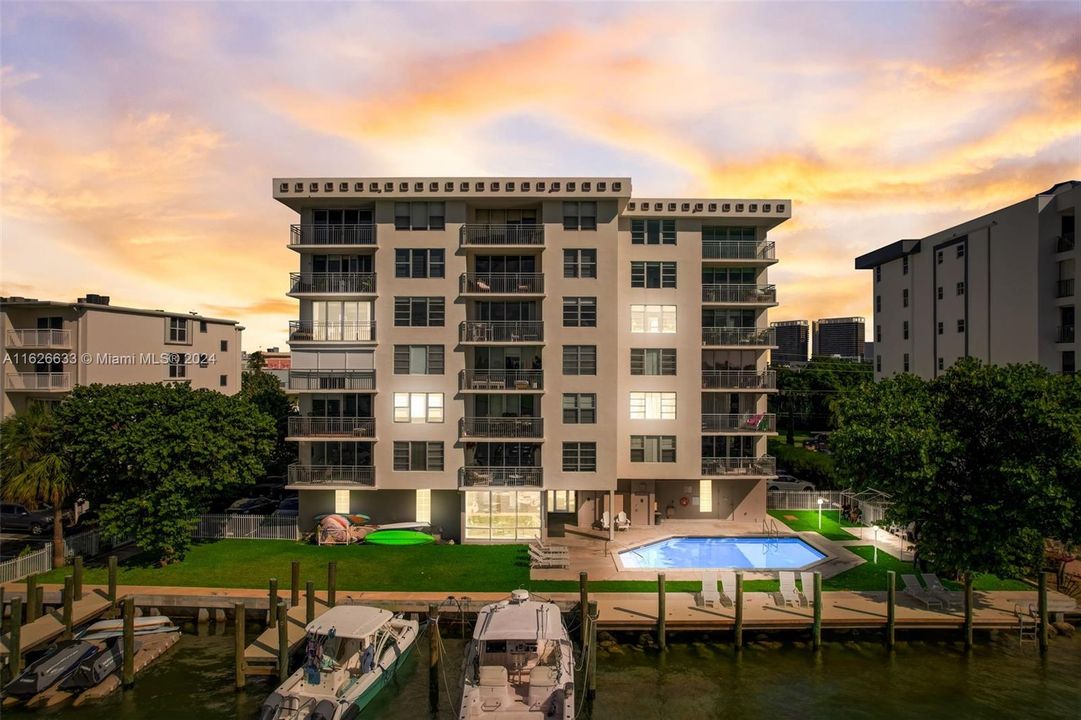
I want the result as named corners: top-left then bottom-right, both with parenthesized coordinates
top-left (273, 177), bottom-right (791, 543)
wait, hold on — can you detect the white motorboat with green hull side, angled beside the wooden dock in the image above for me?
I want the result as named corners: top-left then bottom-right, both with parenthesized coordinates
top-left (259, 605), bottom-right (419, 720)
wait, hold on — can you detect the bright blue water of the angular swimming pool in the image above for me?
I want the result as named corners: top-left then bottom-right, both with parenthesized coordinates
top-left (619, 537), bottom-right (826, 570)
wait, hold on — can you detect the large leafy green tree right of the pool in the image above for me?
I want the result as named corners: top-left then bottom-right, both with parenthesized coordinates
top-left (830, 359), bottom-right (1081, 577)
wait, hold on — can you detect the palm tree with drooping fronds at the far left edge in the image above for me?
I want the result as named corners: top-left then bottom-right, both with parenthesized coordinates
top-left (0, 403), bottom-right (75, 568)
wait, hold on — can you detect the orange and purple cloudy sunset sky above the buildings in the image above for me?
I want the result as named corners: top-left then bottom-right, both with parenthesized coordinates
top-left (0, 0), bottom-right (1081, 350)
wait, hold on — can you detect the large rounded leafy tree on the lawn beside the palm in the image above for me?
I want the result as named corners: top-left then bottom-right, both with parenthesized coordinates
top-left (57, 384), bottom-right (273, 563)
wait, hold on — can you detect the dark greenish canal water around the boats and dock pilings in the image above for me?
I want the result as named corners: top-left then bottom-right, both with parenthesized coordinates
top-left (3, 626), bottom-right (1081, 720)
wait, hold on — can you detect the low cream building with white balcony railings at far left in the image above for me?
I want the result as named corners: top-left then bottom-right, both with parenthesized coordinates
top-left (0, 295), bottom-right (243, 417)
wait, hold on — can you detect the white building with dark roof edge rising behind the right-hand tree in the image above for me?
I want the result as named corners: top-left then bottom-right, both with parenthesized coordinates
top-left (856, 181), bottom-right (1081, 378)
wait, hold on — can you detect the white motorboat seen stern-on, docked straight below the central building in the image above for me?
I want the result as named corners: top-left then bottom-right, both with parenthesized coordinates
top-left (458, 590), bottom-right (574, 720)
